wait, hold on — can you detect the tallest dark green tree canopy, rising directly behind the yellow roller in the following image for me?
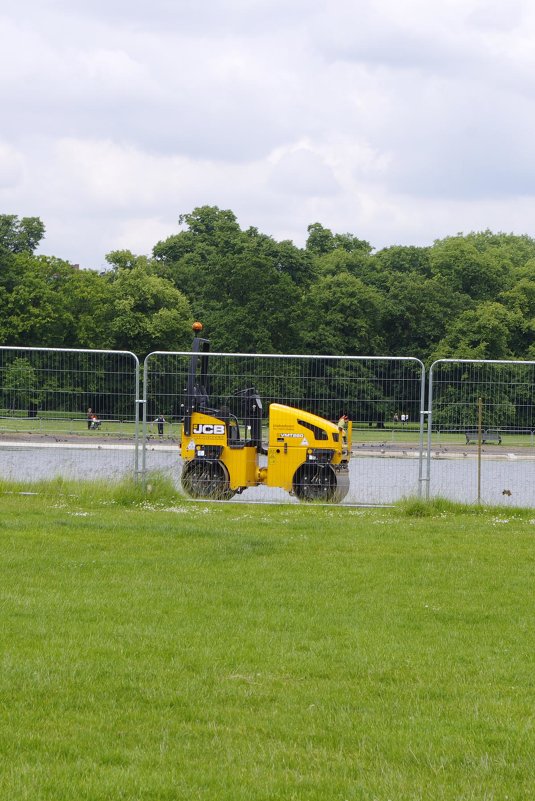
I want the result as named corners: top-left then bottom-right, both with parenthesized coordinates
top-left (153, 206), bottom-right (312, 353)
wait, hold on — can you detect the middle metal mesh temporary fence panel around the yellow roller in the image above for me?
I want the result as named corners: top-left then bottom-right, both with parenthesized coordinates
top-left (142, 352), bottom-right (425, 505)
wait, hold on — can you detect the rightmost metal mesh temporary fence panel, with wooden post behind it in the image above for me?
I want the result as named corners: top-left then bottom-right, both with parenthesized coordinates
top-left (426, 359), bottom-right (535, 507)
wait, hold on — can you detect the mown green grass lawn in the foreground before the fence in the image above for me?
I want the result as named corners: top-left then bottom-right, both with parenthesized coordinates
top-left (0, 481), bottom-right (535, 801)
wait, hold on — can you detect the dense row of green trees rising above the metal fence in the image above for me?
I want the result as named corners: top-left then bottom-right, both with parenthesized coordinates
top-left (0, 206), bottom-right (535, 363)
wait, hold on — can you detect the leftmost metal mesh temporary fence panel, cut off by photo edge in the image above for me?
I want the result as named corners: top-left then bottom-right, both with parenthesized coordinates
top-left (0, 346), bottom-right (140, 481)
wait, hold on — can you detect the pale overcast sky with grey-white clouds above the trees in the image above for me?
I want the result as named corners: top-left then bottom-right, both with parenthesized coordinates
top-left (0, 0), bottom-right (535, 269)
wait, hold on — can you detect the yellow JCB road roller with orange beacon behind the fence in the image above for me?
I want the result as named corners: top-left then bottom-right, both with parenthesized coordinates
top-left (180, 323), bottom-right (351, 502)
